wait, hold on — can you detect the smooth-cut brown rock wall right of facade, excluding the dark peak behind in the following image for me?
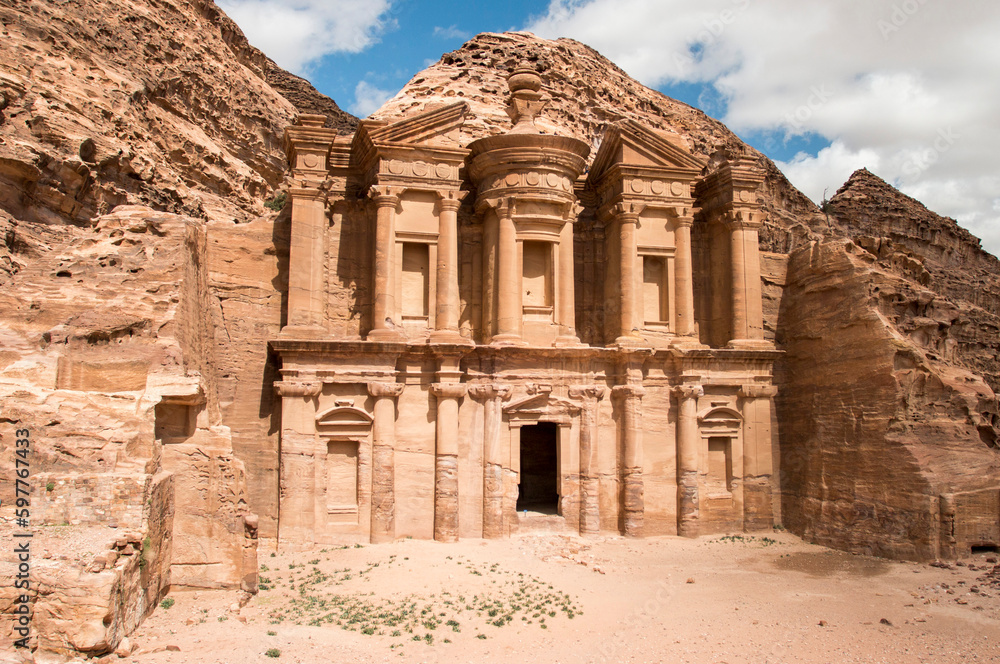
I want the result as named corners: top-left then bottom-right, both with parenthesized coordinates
top-left (778, 241), bottom-right (1000, 560)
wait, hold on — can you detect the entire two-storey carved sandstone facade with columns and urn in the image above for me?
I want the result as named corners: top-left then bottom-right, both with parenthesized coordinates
top-left (271, 70), bottom-right (777, 544)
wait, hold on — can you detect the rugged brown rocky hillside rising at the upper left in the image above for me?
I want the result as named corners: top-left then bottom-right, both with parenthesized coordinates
top-left (0, 0), bottom-right (355, 239)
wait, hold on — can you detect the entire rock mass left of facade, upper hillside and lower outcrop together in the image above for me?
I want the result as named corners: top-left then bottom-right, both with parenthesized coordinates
top-left (0, 0), bottom-right (340, 654)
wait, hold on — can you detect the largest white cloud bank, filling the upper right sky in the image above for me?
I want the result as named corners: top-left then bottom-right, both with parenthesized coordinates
top-left (527, 0), bottom-right (1000, 254)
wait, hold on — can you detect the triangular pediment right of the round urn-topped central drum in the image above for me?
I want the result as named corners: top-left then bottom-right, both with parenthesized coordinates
top-left (590, 120), bottom-right (705, 181)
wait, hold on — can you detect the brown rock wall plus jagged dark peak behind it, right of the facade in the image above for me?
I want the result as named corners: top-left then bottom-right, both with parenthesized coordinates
top-left (778, 170), bottom-right (1000, 559)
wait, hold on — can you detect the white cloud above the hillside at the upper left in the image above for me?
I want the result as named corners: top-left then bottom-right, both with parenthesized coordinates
top-left (218, 0), bottom-right (390, 74)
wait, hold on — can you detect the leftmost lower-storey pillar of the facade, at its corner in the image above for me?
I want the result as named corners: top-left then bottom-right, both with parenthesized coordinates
top-left (274, 380), bottom-right (323, 542)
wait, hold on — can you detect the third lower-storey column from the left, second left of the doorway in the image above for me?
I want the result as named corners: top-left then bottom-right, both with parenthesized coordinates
top-left (431, 383), bottom-right (466, 542)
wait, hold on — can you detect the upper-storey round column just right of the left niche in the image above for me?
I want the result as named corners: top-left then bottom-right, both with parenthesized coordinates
top-left (431, 191), bottom-right (468, 343)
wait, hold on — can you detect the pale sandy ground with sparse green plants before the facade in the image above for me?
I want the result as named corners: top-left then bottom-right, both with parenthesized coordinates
top-left (125, 533), bottom-right (1000, 664)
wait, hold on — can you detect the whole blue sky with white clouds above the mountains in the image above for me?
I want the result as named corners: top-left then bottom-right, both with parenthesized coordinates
top-left (217, 0), bottom-right (1000, 254)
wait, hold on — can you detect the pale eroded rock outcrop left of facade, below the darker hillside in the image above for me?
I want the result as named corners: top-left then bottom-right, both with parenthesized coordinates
top-left (0, 206), bottom-right (257, 653)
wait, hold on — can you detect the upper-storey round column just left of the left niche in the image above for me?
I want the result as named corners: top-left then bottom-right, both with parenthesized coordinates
top-left (368, 187), bottom-right (400, 341)
